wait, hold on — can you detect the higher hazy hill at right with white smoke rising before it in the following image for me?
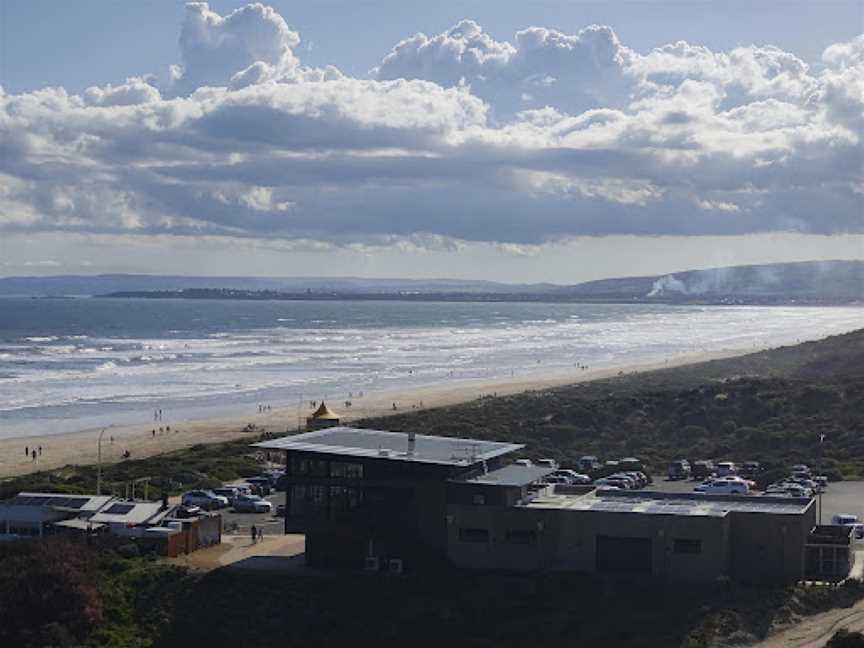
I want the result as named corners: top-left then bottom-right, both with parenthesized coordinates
top-left (554, 261), bottom-right (864, 303)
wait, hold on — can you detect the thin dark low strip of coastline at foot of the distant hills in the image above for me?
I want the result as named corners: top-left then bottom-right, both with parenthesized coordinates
top-left (94, 288), bottom-right (864, 306)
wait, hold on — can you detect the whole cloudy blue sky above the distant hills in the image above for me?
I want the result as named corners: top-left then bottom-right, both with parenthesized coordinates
top-left (0, 0), bottom-right (864, 283)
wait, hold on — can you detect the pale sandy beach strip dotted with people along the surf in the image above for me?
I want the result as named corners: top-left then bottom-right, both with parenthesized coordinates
top-left (0, 348), bottom-right (754, 478)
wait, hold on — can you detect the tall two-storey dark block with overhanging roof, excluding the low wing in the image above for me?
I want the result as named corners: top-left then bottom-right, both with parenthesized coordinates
top-left (255, 427), bottom-right (522, 567)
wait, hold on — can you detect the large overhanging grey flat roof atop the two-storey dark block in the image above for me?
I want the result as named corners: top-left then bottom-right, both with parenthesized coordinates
top-left (252, 426), bottom-right (525, 466)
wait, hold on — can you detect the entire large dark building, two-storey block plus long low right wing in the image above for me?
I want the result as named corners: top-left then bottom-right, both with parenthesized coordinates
top-left (256, 427), bottom-right (825, 583)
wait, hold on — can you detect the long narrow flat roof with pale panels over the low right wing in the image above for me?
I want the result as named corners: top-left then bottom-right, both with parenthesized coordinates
top-left (525, 491), bottom-right (812, 517)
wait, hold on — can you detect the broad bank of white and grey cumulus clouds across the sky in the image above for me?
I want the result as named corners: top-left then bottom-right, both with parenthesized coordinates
top-left (0, 3), bottom-right (864, 253)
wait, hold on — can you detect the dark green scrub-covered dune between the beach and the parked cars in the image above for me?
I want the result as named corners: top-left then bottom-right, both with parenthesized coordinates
top-left (361, 331), bottom-right (864, 479)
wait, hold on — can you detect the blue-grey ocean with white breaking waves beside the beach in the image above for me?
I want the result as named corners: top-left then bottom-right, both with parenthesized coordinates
top-left (0, 298), bottom-right (864, 438)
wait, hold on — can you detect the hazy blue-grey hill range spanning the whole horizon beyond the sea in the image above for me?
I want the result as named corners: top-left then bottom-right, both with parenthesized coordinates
top-left (0, 261), bottom-right (864, 304)
